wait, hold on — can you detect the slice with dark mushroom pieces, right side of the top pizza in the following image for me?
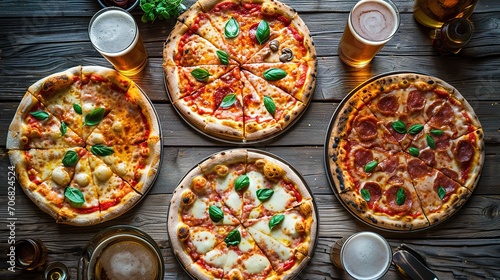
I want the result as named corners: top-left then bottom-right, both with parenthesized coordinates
top-left (245, 16), bottom-right (317, 64)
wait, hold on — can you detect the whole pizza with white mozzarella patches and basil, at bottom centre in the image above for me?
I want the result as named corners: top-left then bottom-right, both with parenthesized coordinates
top-left (168, 149), bottom-right (318, 280)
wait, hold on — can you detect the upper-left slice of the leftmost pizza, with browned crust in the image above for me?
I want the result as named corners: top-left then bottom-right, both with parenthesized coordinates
top-left (28, 66), bottom-right (83, 137)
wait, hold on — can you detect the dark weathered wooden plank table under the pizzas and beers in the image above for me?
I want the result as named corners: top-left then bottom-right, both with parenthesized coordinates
top-left (0, 0), bottom-right (500, 279)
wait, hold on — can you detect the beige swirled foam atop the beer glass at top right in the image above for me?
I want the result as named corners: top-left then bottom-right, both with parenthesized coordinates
top-left (349, 0), bottom-right (398, 42)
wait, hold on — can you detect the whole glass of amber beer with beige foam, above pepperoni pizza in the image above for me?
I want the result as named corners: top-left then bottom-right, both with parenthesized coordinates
top-left (339, 0), bottom-right (399, 67)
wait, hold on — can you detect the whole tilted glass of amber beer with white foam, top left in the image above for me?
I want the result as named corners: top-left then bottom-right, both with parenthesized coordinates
top-left (88, 7), bottom-right (148, 76)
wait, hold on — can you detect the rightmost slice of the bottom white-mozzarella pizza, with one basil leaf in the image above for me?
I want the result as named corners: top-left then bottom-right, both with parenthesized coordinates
top-left (243, 200), bottom-right (317, 256)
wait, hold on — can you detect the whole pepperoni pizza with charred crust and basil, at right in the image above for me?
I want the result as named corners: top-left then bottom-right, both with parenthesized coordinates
top-left (326, 73), bottom-right (484, 231)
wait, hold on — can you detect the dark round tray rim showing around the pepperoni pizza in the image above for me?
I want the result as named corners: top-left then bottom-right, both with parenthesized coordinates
top-left (324, 71), bottom-right (484, 233)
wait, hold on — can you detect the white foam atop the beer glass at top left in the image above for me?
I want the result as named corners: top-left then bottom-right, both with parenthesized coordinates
top-left (89, 11), bottom-right (137, 54)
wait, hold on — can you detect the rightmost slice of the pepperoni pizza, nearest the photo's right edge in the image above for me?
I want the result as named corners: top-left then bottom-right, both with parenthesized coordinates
top-left (407, 129), bottom-right (484, 191)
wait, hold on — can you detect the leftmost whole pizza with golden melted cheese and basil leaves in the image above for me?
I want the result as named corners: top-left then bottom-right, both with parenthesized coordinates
top-left (7, 66), bottom-right (161, 226)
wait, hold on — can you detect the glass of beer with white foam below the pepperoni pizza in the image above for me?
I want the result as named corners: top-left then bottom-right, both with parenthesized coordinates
top-left (330, 231), bottom-right (392, 280)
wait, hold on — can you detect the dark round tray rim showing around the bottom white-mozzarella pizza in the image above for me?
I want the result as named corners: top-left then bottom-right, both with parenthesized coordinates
top-left (167, 149), bottom-right (319, 279)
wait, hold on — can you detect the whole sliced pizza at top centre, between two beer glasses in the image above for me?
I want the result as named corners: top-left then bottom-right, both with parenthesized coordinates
top-left (163, 0), bottom-right (317, 142)
